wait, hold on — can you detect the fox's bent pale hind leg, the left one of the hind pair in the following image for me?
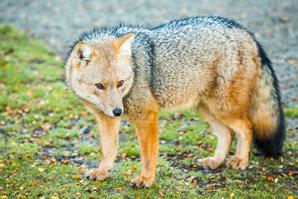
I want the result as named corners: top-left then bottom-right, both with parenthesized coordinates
top-left (197, 107), bottom-right (232, 169)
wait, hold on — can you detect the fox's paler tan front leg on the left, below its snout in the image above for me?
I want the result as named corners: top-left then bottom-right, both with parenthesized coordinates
top-left (87, 115), bottom-right (120, 181)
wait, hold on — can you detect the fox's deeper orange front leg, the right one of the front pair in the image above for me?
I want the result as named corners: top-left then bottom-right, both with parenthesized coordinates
top-left (132, 112), bottom-right (158, 187)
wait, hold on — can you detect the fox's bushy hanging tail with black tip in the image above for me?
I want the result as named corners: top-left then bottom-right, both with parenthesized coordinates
top-left (250, 41), bottom-right (285, 157)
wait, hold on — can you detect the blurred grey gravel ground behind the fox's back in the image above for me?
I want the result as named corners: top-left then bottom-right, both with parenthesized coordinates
top-left (0, 0), bottom-right (298, 106)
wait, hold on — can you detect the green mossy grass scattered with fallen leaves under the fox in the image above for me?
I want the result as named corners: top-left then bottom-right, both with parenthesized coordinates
top-left (0, 25), bottom-right (298, 199)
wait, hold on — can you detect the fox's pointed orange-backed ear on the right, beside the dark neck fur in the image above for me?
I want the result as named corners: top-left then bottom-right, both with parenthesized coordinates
top-left (113, 33), bottom-right (135, 55)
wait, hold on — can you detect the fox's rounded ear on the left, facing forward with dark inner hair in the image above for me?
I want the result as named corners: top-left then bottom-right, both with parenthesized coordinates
top-left (73, 41), bottom-right (94, 66)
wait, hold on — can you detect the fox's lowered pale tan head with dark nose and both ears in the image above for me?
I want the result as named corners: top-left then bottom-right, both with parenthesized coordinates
top-left (66, 34), bottom-right (134, 117)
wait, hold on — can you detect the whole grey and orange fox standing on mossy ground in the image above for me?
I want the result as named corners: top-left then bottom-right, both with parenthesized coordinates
top-left (65, 16), bottom-right (285, 187)
